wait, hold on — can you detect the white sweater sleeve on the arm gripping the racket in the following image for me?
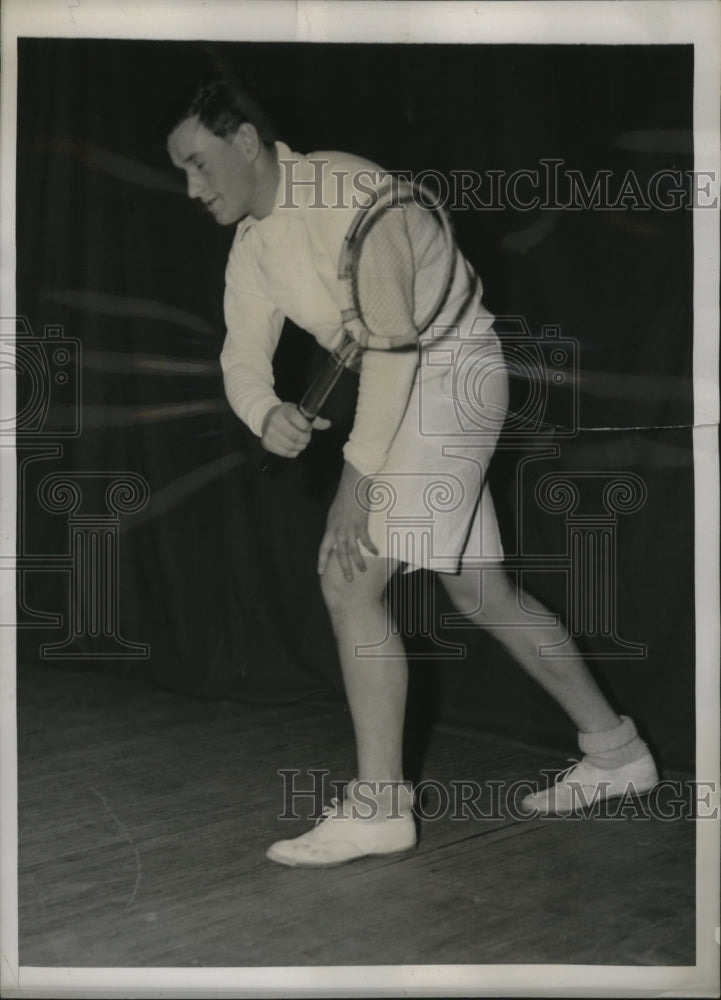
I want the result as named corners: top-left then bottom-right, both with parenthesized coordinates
top-left (220, 238), bottom-right (284, 437)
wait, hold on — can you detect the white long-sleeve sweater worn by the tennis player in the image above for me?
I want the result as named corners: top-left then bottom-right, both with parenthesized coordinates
top-left (220, 143), bottom-right (486, 475)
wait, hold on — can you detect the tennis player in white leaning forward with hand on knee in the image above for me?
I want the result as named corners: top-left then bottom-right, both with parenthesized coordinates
top-left (167, 80), bottom-right (658, 867)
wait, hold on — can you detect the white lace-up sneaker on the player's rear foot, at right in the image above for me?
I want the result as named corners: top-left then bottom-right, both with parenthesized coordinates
top-left (521, 754), bottom-right (658, 815)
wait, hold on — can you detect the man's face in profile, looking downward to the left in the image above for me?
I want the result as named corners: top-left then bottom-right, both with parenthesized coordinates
top-left (168, 118), bottom-right (259, 226)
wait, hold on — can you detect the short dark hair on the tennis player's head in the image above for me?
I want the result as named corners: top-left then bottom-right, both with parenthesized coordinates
top-left (165, 77), bottom-right (267, 142)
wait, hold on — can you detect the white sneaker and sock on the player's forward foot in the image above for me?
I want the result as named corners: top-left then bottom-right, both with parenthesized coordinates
top-left (265, 781), bottom-right (416, 868)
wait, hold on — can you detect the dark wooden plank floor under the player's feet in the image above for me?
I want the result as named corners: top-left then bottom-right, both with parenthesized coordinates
top-left (18, 666), bottom-right (694, 967)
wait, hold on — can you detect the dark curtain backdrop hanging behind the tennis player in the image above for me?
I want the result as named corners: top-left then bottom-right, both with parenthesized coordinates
top-left (17, 39), bottom-right (694, 767)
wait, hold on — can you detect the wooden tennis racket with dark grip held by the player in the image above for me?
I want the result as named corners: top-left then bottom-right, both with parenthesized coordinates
top-left (261, 179), bottom-right (456, 477)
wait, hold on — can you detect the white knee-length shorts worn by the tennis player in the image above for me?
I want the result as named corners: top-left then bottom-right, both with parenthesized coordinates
top-left (363, 329), bottom-right (508, 573)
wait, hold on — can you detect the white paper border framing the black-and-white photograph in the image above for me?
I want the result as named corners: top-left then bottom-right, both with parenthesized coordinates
top-left (0, 0), bottom-right (721, 997)
